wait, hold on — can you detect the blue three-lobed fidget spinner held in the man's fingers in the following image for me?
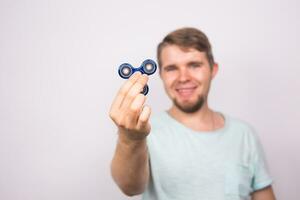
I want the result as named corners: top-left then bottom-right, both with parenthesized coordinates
top-left (118, 59), bottom-right (157, 95)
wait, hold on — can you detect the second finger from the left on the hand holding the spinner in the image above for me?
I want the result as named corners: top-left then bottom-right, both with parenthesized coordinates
top-left (121, 74), bottom-right (148, 110)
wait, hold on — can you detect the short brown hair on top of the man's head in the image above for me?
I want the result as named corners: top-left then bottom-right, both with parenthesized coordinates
top-left (157, 27), bottom-right (215, 68)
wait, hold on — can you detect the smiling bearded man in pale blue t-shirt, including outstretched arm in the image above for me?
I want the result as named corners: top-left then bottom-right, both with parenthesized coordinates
top-left (110, 28), bottom-right (275, 200)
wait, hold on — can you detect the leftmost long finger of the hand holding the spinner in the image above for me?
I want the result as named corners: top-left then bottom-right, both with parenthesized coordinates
top-left (111, 71), bottom-right (142, 114)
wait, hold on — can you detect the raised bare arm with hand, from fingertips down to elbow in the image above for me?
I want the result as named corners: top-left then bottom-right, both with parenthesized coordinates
top-left (110, 73), bottom-right (151, 196)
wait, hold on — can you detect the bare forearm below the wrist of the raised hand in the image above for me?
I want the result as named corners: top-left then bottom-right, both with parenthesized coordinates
top-left (111, 135), bottom-right (149, 196)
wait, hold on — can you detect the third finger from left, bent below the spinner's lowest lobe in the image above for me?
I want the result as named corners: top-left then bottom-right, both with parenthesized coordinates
top-left (126, 94), bottom-right (146, 128)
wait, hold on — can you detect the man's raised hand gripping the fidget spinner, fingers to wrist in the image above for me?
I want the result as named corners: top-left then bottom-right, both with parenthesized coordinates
top-left (109, 72), bottom-right (151, 142)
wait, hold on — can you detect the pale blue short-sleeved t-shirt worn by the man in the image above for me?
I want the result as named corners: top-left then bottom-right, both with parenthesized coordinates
top-left (142, 112), bottom-right (272, 200)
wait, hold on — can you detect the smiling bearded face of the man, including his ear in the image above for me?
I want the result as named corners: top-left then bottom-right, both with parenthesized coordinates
top-left (160, 45), bottom-right (218, 113)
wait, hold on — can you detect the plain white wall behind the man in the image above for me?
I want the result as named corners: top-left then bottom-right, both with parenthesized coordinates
top-left (0, 0), bottom-right (300, 200)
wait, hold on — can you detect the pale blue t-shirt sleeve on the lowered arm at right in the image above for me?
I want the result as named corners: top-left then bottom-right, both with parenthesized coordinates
top-left (252, 131), bottom-right (273, 191)
